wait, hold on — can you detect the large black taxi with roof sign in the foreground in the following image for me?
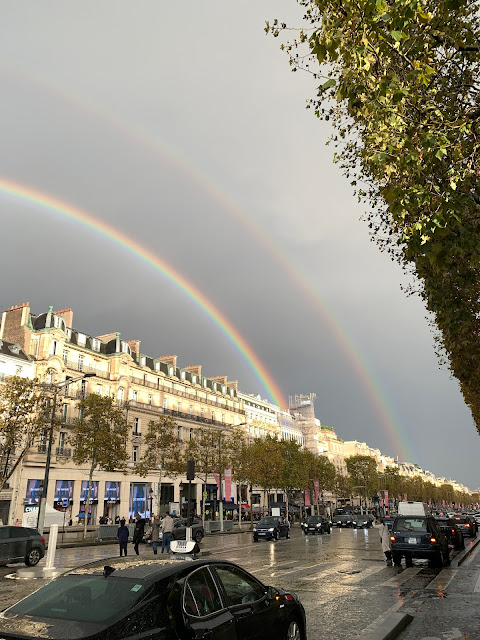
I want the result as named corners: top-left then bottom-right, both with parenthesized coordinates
top-left (0, 558), bottom-right (306, 640)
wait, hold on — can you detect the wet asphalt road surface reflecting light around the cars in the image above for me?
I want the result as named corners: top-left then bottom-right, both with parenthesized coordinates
top-left (0, 525), bottom-right (480, 640)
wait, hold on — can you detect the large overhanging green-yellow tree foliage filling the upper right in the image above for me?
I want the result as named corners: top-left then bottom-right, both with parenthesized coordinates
top-left (266, 0), bottom-right (480, 431)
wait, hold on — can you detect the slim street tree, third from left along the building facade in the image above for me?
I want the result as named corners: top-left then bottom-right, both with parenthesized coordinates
top-left (136, 416), bottom-right (181, 515)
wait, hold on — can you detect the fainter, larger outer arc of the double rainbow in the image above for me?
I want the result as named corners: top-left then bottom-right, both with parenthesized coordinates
top-left (0, 60), bottom-right (415, 460)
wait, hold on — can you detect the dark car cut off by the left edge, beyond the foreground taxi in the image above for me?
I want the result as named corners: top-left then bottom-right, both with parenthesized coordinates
top-left (0, 525), bottom-right (45, 567)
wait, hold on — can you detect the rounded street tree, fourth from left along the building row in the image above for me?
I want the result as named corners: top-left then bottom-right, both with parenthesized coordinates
top-left (183, 425), bottom-right (235, 525)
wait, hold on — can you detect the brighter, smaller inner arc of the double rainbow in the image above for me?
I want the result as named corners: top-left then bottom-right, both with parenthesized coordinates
top-left (0, 179), bottom-right (286, 407)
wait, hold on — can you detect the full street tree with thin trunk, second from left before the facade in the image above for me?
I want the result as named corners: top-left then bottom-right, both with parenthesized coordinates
top-left (68, 393), bottom-right (130, 540)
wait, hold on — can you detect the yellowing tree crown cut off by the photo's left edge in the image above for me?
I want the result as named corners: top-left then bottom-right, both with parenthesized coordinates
top-left (0, 376), bottom-right (50, 491)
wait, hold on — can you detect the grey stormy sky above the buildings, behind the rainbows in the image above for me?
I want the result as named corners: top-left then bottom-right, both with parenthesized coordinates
top-left (0, 0), bottom-right (480, 490)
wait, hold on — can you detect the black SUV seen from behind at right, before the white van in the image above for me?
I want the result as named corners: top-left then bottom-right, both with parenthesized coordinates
top-left (390, 515), bottom-right (450, 567)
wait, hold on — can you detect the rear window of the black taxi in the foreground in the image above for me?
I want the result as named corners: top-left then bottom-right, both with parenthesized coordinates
top-left (8, 575), bottom-right (147, 623)
